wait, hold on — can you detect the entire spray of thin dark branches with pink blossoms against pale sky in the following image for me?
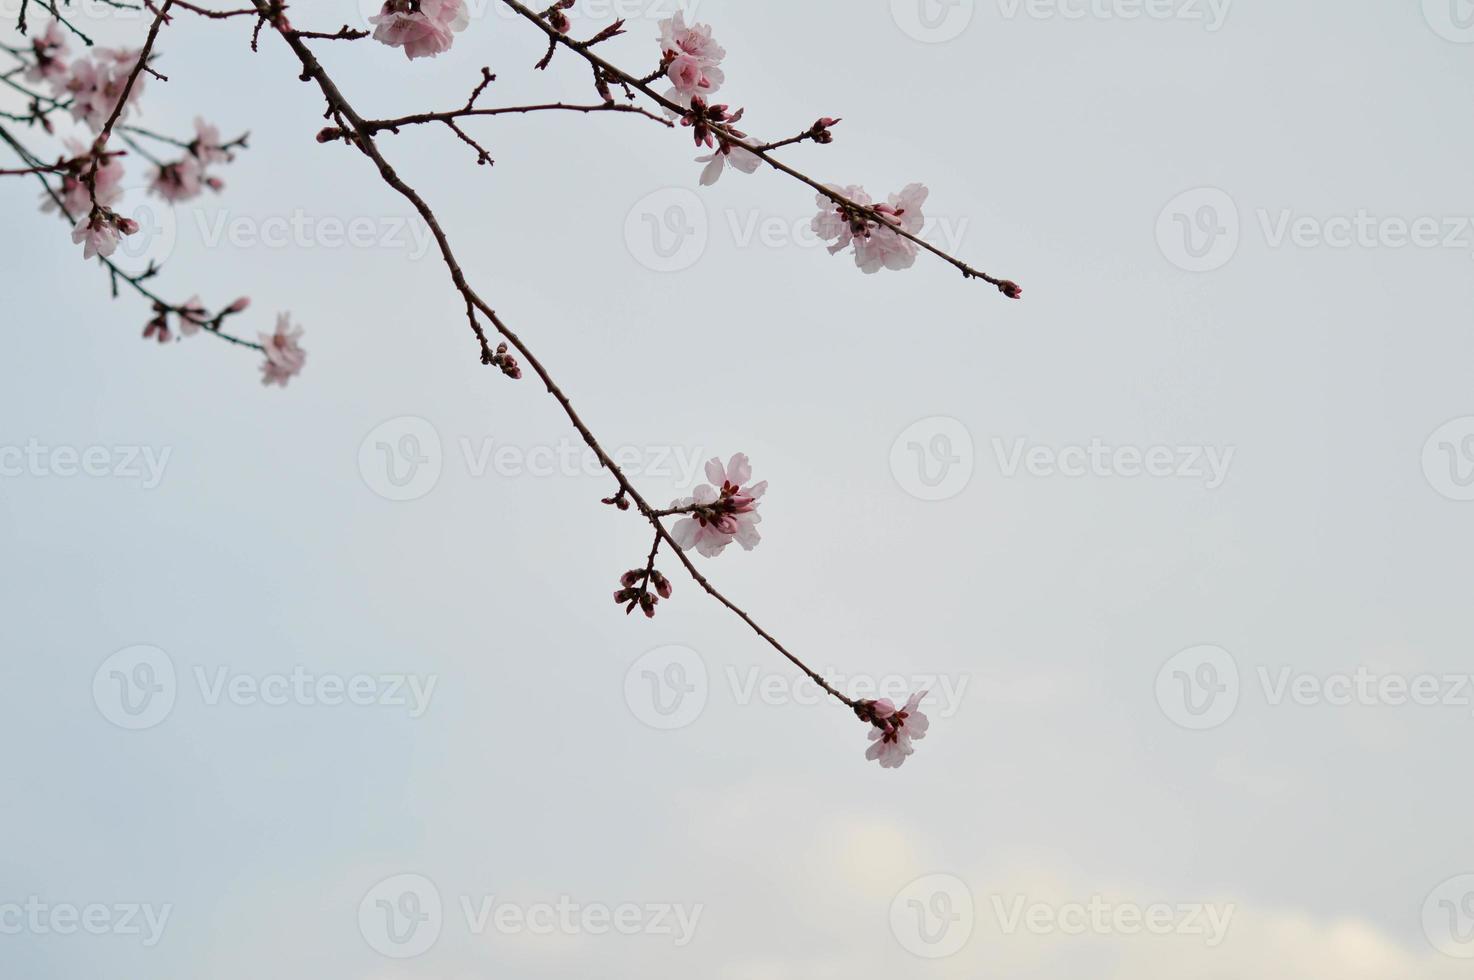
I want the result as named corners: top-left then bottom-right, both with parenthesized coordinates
top-left (0, 0), bottom-right (1021, 768)
